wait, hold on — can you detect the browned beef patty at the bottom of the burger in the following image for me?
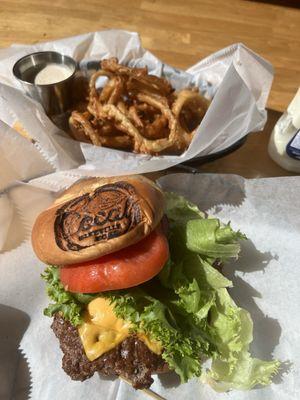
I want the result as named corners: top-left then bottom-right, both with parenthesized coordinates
top-left (51, 314), bottom-right (166, 389)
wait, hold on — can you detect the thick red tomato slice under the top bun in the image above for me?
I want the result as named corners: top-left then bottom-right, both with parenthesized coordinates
top-left (60, 229), bottom-right (169, 293)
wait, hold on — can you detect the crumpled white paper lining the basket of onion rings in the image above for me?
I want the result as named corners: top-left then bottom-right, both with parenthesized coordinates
top-left (0, 30), bottom-right (273, 176)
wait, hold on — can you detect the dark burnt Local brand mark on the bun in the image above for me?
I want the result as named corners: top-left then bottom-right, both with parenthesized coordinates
top-left (54, 181), bottom-right (142, 251)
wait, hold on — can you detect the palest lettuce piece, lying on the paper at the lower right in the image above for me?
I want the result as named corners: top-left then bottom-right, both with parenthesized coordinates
top-left (201, 289), bottom-right (280, 391)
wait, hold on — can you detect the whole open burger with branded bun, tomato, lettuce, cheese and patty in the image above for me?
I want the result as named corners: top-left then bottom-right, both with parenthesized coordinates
top-left (32, 176), bottom-right (279, 390)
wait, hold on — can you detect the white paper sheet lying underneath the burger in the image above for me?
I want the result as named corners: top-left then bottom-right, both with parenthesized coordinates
top-left (0, 173), bottom-right (300, 400)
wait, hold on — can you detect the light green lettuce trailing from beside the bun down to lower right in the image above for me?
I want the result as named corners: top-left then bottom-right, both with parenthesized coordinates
top-left (159, 195), bottom-right (280, 391)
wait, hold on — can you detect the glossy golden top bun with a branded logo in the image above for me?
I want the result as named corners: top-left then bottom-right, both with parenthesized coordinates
top-left (31, 175), bottom-right (164, 265)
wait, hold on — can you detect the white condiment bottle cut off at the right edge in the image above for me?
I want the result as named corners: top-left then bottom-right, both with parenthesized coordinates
top-left (268, 88), bottom-right (300, 172)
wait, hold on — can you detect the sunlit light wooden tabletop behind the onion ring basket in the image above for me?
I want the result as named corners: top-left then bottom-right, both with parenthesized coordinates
top-left (0, 0), bottom-right (300, 111)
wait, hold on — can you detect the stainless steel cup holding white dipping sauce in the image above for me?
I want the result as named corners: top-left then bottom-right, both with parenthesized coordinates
top-left (13, 51), bottom-right (77, 117)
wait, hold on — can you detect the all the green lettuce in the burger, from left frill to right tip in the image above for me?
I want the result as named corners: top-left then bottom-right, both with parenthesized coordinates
top-left (43, 193), bottom-right (279, 391)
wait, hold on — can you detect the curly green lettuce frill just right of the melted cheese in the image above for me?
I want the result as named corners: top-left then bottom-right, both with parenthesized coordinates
top-left (106, 284), bottom-right (206, 382)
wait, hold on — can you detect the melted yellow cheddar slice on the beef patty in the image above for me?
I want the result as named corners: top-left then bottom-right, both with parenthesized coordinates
top-left (78, 297), bottom-right (162, 361)
